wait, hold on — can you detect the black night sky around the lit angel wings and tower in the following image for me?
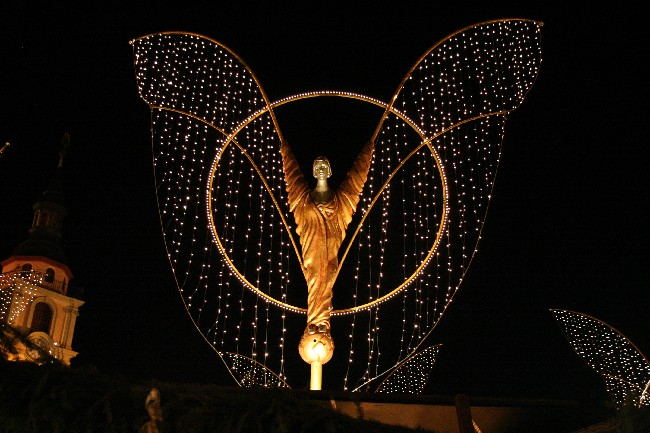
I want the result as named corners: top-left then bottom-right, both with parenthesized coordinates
top-left (0, 2), bottom-right (650, 399)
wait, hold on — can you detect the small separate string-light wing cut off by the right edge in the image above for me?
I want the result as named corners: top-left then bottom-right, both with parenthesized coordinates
top-left (551, 310), bottom-right (650, 409)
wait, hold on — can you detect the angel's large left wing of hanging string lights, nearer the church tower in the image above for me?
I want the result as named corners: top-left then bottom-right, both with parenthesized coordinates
top-left (132, 33), bottom-right (304, 383)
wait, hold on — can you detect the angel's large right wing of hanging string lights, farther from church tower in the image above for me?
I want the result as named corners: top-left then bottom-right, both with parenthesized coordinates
top-left (334, 19), bottom-right (541, 383)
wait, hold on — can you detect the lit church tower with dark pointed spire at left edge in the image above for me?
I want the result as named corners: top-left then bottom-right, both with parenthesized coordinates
top-left (0, 134), bottom-right (84, 365)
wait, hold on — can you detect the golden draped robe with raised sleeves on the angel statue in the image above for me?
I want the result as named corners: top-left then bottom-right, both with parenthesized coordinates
top-left (281, 142), bottom-right (374, 332)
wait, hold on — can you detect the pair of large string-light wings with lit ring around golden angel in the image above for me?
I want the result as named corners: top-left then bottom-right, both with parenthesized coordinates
top-left (132, 19), bottom-right (541, 390)
